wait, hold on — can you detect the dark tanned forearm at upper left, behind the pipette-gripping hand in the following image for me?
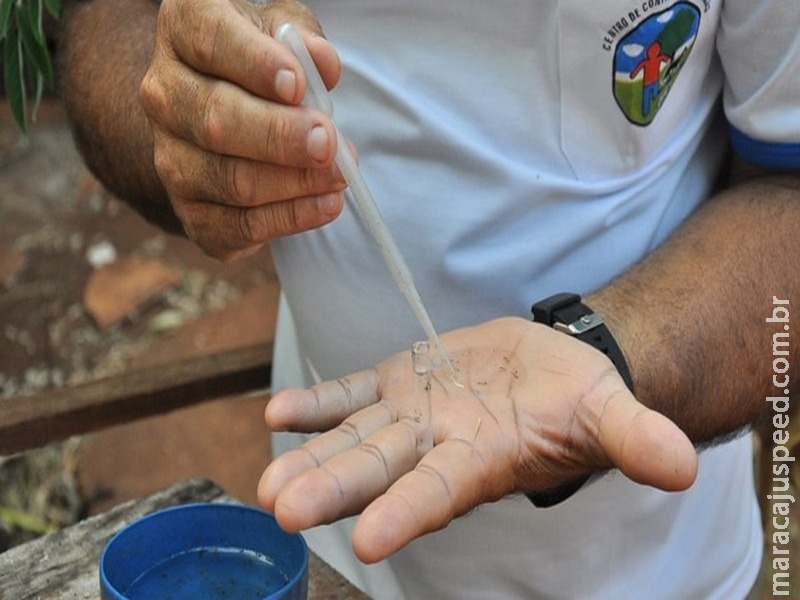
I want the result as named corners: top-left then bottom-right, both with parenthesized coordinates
top-left (58, 0), bottom-right (182, 232)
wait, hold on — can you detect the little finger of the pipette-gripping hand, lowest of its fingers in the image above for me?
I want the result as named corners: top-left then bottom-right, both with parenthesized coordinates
top-left (173, 193), bottom-right (344, 262)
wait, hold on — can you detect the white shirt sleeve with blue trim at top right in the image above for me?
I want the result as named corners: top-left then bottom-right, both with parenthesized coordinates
top-left (717, 0), bottom-right (800, 169)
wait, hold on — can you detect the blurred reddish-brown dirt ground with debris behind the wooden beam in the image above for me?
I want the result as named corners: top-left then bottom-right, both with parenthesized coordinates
top-left (0, 101), bottom-right (800, 598)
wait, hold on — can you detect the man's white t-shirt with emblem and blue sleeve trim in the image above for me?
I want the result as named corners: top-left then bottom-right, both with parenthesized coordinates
top-left (273, 0), bottom-right (800, 600)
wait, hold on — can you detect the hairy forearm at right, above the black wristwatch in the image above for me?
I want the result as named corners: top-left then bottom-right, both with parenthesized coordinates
top-left (587, 166), bottom-right (800, 443)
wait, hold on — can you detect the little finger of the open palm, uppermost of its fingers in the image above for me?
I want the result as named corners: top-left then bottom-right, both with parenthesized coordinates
top-left (265, 369), bottom-right (380, 431)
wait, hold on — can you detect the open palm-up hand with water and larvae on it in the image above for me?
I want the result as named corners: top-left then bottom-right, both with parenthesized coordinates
top-left (259, 318), bottom-right (697, 562)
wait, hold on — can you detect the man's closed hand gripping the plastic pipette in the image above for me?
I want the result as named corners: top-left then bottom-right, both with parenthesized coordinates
top-left (140, 0), bottom-right (346, 260)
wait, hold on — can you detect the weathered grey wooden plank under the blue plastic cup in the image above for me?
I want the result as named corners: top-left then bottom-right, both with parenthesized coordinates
top-left (0, 479), bottom-right (366, 600)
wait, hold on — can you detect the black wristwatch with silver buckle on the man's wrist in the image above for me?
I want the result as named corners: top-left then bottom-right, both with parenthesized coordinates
top-left (525, 293), bottom-right (633, 508)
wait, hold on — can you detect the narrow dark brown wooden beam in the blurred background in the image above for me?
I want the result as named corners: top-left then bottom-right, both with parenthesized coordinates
top-left (0, 342), bottom-right (272, 455)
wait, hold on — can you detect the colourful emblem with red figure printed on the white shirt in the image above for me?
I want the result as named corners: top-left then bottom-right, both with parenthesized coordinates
top-left (614, 2), bottom-right (700, 126)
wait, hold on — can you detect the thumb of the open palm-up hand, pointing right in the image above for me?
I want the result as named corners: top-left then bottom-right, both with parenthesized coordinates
top-left (598, 390), bottom-right (697, 491)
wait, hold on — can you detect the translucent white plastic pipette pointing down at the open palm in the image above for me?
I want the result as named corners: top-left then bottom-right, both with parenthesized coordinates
top-left (275, 23), bottom-right (455, 380)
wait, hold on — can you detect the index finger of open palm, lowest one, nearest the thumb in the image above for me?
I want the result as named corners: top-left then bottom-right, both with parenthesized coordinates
top-left (353, 440), bottom-right (494, 563)
